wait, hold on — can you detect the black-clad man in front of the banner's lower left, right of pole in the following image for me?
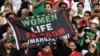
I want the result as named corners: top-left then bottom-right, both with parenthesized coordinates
top-left (19, 40), bottom-right (36, 56)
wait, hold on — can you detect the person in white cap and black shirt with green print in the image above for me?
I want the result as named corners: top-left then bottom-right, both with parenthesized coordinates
top-left (78, 18), bottom-right (99, 56)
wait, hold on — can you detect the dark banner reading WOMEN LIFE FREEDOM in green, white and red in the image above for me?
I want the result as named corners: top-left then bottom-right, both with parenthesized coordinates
top-left (9, 10), bottom-right (74, 46)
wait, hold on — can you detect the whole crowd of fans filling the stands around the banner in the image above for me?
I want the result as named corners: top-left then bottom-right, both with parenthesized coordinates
top-left (0, 0), bottom-right (100, 56)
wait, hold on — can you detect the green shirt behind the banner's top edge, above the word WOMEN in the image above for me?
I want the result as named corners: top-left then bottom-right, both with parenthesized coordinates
top-left (32, 0), bottom-right (45, 16)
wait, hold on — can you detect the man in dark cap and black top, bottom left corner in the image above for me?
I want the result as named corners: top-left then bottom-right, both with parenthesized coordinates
top-left (0, 37), bottom-right (20, 56)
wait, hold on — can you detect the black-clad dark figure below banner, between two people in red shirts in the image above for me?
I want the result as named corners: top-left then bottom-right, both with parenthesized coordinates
top-left (53, 38), bottom-right (71, 56)
